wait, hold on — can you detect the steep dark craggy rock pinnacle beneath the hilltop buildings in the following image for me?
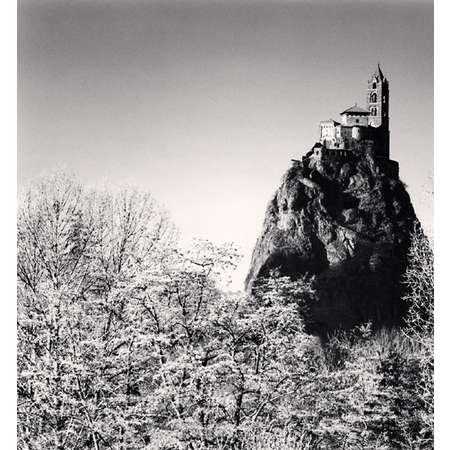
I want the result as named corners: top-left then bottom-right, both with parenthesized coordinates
top-left (246, 150), bottom-right (417, 334)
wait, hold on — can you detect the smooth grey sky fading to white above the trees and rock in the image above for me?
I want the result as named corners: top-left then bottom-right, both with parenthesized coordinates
top-left (18, 0), bottom-right (433, 287)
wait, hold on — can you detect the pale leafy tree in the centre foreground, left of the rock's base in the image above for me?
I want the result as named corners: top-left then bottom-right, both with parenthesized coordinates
top-left (131, 260), bottom-right (320, 448)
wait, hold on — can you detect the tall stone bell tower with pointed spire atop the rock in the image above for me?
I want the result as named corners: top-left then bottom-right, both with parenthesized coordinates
top-left (367, 64), bottom-right (389, 158)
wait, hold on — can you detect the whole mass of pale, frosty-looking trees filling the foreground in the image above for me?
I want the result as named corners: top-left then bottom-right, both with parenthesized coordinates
top-left (17, 176), bottom-right (433, 450)
